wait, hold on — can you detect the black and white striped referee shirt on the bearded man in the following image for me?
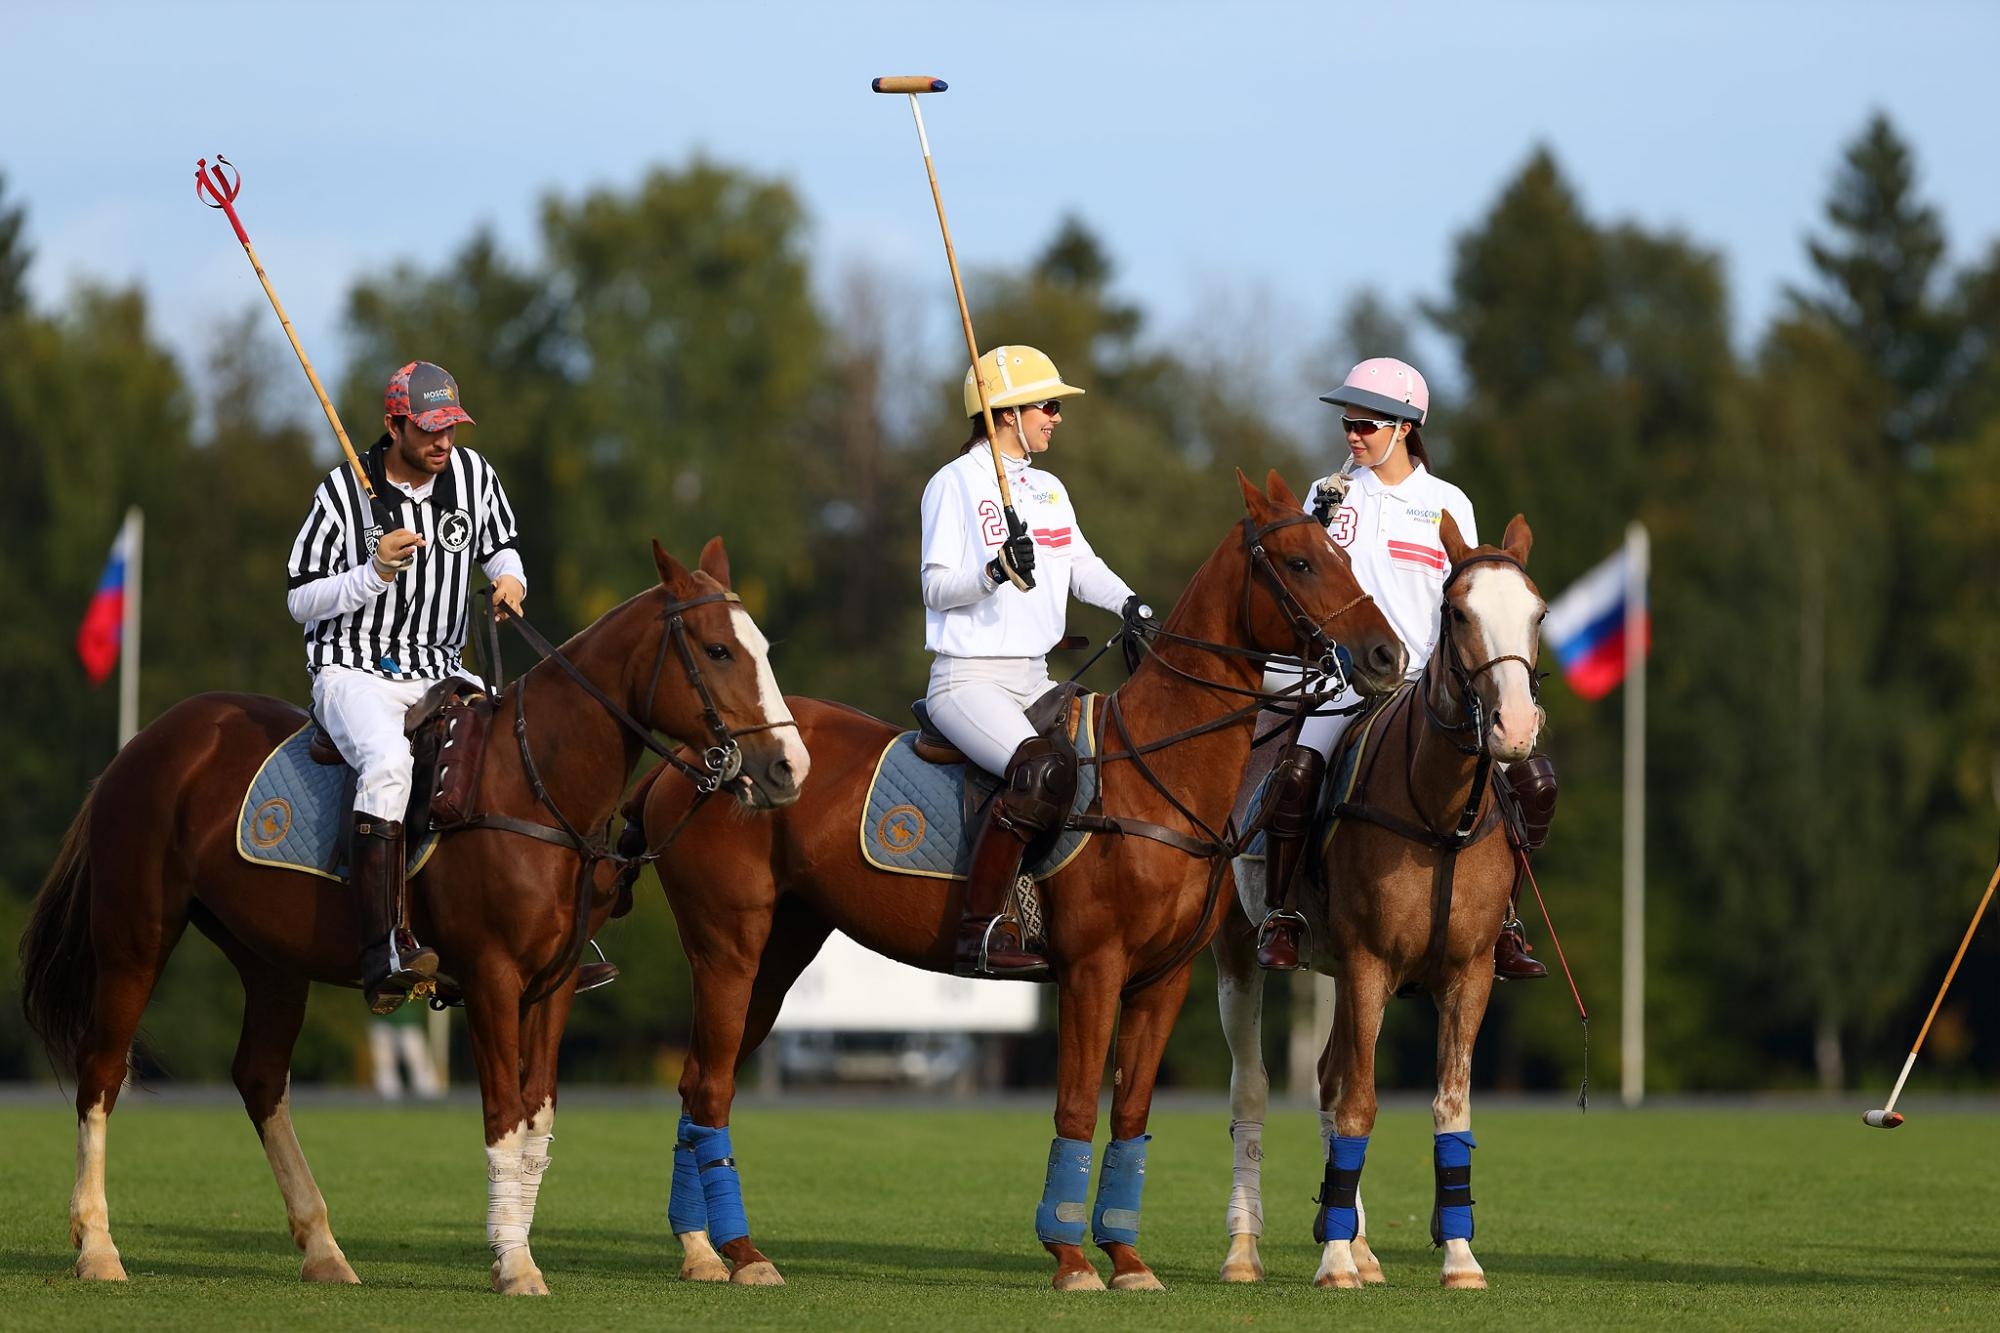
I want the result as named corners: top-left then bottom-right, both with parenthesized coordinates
top-left (286, 434), bottom-right (526, 681)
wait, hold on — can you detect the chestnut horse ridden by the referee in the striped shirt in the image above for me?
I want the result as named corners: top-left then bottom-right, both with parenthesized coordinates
top-left (20, 538), bottom-right (808, 1295)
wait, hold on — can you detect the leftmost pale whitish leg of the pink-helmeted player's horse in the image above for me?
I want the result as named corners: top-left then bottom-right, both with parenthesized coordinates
top-left (1212, 896), bottom-right (1270, 1283)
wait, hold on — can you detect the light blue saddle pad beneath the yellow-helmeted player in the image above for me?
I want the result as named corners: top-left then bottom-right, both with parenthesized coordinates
top-left (860, 695), bottom-right (1098, 879)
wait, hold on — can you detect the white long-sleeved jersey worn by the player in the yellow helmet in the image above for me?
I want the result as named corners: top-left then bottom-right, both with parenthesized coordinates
top-left (922, 446), bottom-right (1132, 656)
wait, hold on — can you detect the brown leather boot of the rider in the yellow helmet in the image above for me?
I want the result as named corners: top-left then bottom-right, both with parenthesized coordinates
top-left (952, 737), bottom-right (1076, 981)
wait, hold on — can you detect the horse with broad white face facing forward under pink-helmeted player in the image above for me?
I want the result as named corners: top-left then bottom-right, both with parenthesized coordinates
top-left (1214, 514), bottom-right (1544, 1287)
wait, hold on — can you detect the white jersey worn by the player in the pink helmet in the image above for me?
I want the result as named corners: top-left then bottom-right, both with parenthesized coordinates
top-left (1308, 462), bottom-right (1480, 673)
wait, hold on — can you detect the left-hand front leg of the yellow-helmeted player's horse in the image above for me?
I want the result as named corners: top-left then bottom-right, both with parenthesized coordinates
top-left (1034, 955), bottom-right (1126, 1291)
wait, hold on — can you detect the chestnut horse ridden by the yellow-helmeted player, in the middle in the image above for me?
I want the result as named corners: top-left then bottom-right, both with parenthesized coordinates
top-left (628, 472), bottom-right (1404, 1289)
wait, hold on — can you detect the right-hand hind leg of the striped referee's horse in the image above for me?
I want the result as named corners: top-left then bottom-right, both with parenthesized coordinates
top-left (198, 915), bottom-right (360, 1283)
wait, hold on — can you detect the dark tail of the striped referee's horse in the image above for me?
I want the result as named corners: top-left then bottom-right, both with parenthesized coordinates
top-left (20, 791), bottom-right (98, 1075)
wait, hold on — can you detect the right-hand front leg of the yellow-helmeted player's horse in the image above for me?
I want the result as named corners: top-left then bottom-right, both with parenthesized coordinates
top-left (1090, 948), bottom-right (1194, 1291)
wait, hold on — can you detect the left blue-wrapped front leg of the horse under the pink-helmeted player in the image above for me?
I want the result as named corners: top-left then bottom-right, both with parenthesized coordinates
top-left (1312, 951), bottom-right (1388, 1287)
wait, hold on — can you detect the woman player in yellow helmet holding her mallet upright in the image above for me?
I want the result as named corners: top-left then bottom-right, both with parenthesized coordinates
top-left (922, 346), bottom-right (1140, 977)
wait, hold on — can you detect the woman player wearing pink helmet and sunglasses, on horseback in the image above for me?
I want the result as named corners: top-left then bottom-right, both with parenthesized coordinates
top-left (1258, 356), bottom-right (1556, 979)
